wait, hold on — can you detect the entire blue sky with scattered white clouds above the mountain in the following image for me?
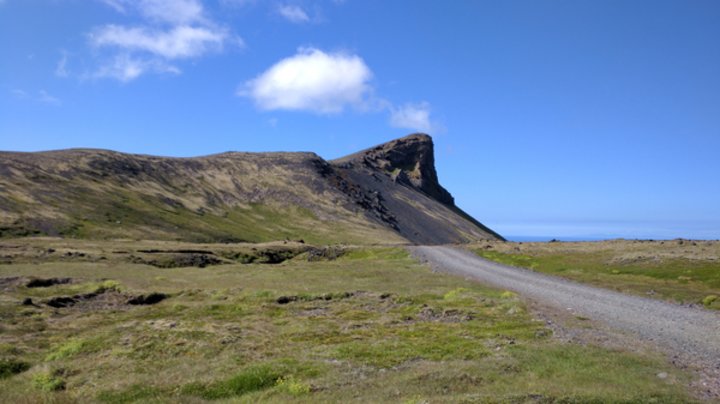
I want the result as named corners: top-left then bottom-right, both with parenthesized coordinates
top-left (0, 0), bottom-right (720, 239)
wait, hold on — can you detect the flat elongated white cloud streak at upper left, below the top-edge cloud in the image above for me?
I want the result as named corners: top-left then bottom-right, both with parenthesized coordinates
top-left (90, 25), bottom-right (228, 59)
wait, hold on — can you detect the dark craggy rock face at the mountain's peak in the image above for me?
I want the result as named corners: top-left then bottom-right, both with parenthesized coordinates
top-left (334, 133), bottom-right (455, 205)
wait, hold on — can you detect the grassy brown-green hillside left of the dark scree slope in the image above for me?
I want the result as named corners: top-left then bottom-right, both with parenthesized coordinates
top-left (0, 150), bottom-right (402, 242)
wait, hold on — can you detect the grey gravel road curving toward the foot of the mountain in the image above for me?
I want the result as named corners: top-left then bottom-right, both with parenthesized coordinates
top-left (411, 246), bottom-right (720, 362)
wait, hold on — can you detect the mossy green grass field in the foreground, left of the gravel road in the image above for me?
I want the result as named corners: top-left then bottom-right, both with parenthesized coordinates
top-left (0, 239), bottom-right (691, 403)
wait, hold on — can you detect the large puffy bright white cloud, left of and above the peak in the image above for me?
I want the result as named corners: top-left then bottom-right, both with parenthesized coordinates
top-left (239, 48), bottom-right (372, 114)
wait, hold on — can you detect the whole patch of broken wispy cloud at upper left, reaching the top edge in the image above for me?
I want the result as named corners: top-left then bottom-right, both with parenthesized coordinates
top-left (88, 0), bottom-right (239, 82)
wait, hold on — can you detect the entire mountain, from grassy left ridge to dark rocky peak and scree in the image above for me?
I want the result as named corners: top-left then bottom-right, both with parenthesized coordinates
top-left (0, 134), bottom-right (502, 244)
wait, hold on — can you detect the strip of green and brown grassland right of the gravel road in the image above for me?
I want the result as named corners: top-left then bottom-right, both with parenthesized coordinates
top-left (472, 240), bottom-right (720, 310)
